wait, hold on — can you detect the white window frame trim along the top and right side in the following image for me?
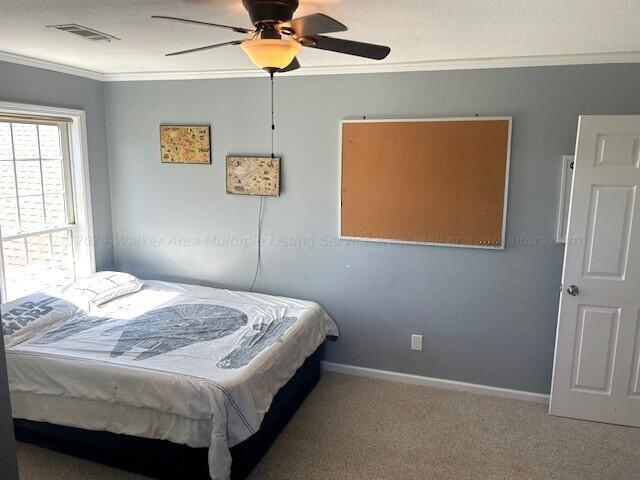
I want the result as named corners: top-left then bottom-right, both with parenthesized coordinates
top-left (0, 101), bottom-right (96, 299)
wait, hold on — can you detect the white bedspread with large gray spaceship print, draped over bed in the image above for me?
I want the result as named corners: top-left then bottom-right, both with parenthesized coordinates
top-left (7, 282), bottom-right (338, 480)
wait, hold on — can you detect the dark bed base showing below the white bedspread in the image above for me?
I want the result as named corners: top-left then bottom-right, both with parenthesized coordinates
top-left (13, 346), bottom-right (324, 480)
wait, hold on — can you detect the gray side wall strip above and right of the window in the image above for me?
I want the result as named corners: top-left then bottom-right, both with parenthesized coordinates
top-left (0, 62), bottom-right (113, 269)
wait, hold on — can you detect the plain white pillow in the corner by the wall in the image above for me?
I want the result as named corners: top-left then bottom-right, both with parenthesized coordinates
top-left (63, 272), bottom-right (144, 308)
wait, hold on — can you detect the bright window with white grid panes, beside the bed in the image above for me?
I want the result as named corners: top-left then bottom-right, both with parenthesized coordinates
top-left (0, 103), bottom-right (93, 301)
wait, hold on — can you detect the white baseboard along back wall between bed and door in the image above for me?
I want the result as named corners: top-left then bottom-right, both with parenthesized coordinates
top-left (322, 362), bottom-right (549, 403)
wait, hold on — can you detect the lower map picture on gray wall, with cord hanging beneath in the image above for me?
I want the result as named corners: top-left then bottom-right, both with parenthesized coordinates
top-left (227, 157), bottom-right (280, 197)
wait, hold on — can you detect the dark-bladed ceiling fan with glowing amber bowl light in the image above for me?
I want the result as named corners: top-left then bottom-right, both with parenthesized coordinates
top-left (152, 0), bottom-right (391, 74)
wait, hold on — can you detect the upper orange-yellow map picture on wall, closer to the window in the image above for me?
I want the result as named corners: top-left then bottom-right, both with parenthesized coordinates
top-left (160, 125), bottom-right (211, 164)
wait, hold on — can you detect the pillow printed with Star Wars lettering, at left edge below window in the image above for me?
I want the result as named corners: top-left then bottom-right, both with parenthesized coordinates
top-left (0, 292), bottom-right (84, 348)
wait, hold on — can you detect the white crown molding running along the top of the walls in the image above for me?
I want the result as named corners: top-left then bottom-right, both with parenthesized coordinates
top-left (0, 51), bottom-right (640, 82)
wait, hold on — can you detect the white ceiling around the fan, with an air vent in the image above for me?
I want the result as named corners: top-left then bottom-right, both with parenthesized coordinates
top-left (0, 0), bottom-right (640, 79)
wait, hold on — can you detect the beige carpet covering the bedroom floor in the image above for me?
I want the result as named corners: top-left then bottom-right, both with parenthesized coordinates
top-left (18, 373), bottom-right (640, 480)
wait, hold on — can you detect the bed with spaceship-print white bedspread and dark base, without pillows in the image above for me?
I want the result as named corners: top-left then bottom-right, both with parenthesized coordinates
top-left (3, 281), bottom-right (338, 480)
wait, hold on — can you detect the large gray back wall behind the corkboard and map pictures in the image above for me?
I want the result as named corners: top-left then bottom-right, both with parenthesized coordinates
top-left (105, 65), bottom-right (640, 392)
